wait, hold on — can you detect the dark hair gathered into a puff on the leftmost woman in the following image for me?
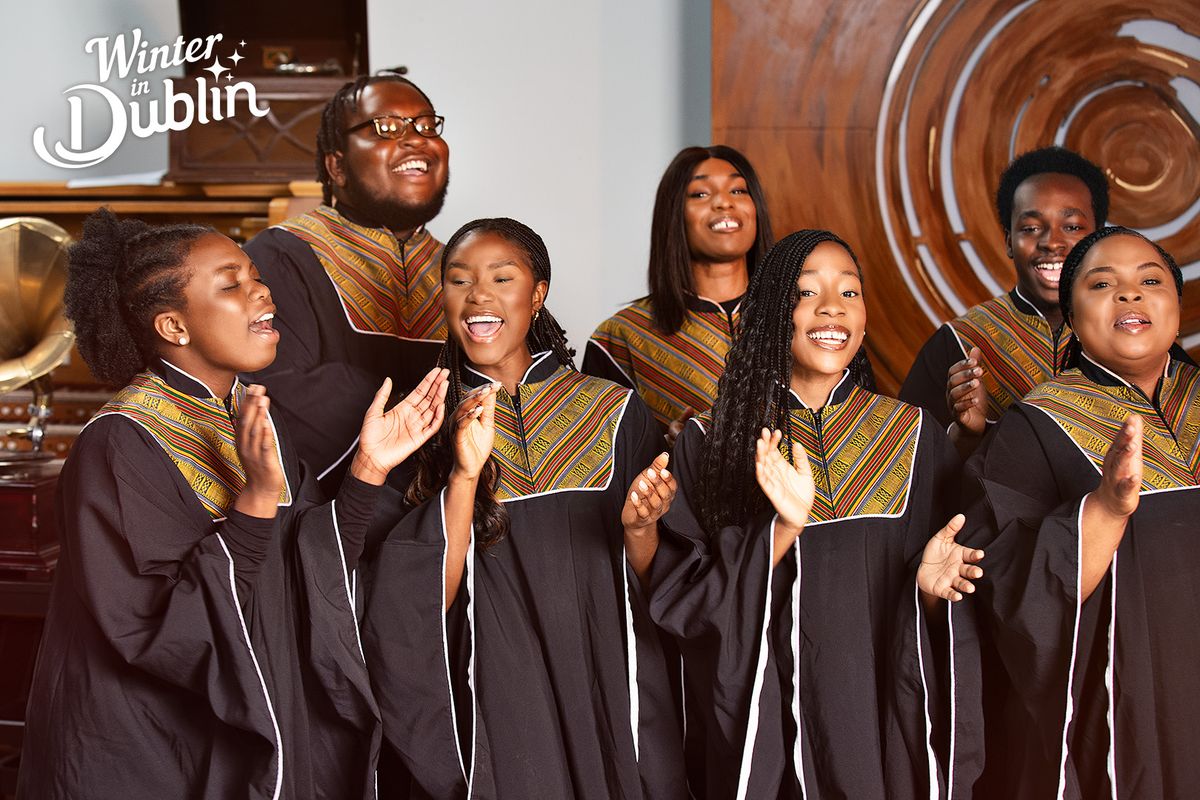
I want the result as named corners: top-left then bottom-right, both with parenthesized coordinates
top-left (64, 207), bottom-right (216, 386)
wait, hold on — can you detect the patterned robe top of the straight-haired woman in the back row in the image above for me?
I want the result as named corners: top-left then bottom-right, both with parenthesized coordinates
top-left (583, 295), bottom-right (742, 432)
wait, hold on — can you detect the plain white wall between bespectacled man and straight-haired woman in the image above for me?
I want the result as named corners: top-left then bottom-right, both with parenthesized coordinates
top-left (368, 0), bottom-right (712, 356)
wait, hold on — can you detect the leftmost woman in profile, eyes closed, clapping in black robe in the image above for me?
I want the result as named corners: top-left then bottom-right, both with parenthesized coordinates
top-left (18, 210), bottom-right (446, 800)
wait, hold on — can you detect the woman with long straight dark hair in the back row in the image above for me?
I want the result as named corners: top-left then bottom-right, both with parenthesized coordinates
top-left (583, 145), bottom-right (774, 441)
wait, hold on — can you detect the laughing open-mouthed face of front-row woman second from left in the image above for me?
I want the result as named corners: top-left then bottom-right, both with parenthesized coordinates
top-left (442, 231), bottom-right (548, 383)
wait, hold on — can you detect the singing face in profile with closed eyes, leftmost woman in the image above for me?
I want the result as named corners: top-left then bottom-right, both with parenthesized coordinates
top-left (155, 234), bottom-right (280, 387)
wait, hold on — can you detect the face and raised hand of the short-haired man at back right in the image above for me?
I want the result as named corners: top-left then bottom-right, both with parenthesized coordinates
top-left (946, 173), bottom-right (1096, 455)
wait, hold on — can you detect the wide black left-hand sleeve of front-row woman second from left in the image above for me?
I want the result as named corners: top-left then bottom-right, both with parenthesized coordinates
top-left (362, 491), bottom-right (470, 798)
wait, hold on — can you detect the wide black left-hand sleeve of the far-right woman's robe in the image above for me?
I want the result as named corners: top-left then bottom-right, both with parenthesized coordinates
top-left (959, 404), bottom-right (1104, 790)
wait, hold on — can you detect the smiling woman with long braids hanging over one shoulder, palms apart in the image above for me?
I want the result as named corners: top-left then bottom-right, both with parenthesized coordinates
top-left (650, 230), bottom-right (982, 799)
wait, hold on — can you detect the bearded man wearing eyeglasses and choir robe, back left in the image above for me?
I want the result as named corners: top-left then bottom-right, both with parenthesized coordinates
top-left (245, 74), bottom-right (450, 497)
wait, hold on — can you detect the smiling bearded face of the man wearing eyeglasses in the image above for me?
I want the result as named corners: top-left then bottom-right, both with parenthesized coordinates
top-left (325, 80), bottom-right (450, 235)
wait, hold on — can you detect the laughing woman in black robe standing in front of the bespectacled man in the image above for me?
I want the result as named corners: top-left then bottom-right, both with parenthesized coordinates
top-left (364, 218), bottom-right (686, 800)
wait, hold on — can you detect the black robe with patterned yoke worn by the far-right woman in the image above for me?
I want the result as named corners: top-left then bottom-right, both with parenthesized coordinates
top-left (956, 355), bottom-right (1200, 800)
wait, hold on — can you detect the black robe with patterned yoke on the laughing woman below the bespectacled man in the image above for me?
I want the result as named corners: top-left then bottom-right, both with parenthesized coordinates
top-left (364, 353), bottom-right (686, 800)
